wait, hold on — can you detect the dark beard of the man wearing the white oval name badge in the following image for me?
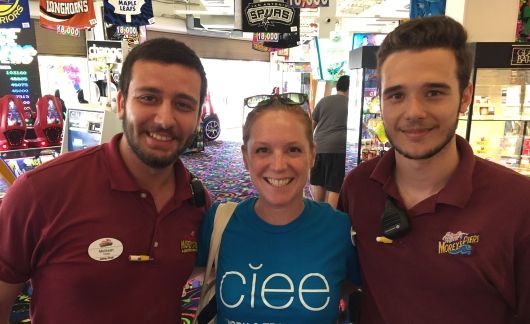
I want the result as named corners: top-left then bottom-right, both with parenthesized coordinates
top-left (122, 111), bottom-right (196, 169)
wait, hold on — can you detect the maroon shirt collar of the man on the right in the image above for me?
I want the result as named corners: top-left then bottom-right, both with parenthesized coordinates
top-left (370, 135), bottom-right (475, 208)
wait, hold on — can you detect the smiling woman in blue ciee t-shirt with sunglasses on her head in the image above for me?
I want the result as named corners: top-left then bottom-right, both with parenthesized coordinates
top-left (197, 93), bottom-right (360, 323)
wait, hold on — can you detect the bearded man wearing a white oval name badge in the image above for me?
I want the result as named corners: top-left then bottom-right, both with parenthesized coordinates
top-left (0, 38), bottom-right (210, 324)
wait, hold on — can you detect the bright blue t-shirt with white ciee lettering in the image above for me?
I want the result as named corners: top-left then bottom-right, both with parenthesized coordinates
top-left (197, 198), bottom-right (360, 324)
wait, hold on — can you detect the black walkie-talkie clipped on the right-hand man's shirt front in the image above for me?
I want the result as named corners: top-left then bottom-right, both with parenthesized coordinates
top-left (381, 197), bottom-right (410, 239)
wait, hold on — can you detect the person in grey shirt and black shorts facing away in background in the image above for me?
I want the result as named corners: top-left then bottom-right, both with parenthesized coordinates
top-left (310, 75), bottom-right (350, 208)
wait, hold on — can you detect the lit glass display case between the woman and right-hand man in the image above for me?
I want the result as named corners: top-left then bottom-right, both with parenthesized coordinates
top-left (347, 46), bottom-right (390, 163)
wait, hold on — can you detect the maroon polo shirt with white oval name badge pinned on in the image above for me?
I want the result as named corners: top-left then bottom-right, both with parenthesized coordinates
top-left (0, 134), bottom-right (209, 324)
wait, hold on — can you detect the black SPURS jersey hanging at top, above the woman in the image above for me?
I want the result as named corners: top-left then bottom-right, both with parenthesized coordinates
top-left (245, 1), bottom-right (295, 30)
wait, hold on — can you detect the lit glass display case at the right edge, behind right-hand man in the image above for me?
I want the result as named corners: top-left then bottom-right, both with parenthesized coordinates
top-left (457, 43), bottom-right (530, 176)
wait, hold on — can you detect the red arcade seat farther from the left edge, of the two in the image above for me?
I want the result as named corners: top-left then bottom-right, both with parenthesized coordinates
top-left (29, 95), bottom-right (63, 147)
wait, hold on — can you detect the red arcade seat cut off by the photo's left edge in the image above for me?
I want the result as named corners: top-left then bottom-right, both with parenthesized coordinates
top-left (0, 94), bottom-right (28, 151)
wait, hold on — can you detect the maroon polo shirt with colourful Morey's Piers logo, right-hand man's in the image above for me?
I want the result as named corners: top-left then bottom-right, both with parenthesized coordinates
top-left (339, 136), bottom-right (530, 324)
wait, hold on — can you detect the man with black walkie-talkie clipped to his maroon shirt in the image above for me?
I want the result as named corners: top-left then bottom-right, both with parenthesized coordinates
top-left (338, 16), bottom-right (530, 324)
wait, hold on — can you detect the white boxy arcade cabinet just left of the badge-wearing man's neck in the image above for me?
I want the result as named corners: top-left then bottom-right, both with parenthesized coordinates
top-left (61, 107), bottom-right (122, 153)
